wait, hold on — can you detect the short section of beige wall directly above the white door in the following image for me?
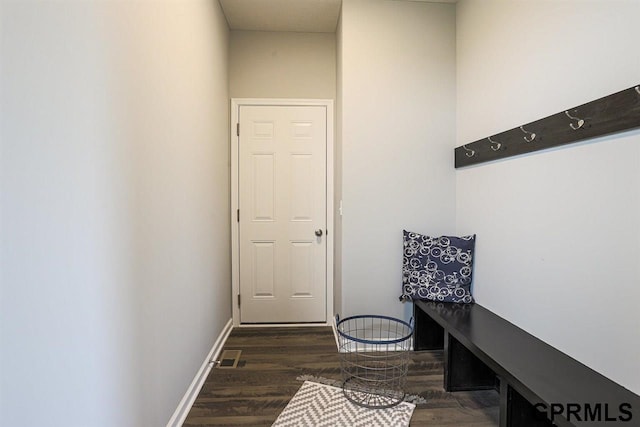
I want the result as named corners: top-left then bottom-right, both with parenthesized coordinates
top-left (229, 31), bottom-right (336, 99)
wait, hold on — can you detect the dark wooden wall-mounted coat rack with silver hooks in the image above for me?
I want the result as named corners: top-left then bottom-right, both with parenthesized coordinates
top-left (455, 85), bottom-right (640, 168)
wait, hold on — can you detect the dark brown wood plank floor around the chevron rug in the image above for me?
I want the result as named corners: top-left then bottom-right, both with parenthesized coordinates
top-left (184, 327), bottom-right (499, 427)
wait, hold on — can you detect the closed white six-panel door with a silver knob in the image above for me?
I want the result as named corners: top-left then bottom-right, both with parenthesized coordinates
top-left (238, 105), bottom-right (327, 323)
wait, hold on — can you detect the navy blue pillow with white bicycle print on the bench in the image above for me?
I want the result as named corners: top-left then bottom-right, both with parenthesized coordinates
top-left (400, 230), bottom-right (476, 303)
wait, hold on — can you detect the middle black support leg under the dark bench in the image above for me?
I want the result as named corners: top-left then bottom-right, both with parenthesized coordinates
top-left (444, 333), bottom-right (498, 391)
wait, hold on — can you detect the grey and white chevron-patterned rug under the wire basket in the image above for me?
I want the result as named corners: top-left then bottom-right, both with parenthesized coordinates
top-left (273, 381), bottom-right (415, 427)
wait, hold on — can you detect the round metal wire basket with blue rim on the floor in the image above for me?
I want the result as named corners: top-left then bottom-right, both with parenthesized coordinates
top-left (336, 315), bottom-right (413, 408)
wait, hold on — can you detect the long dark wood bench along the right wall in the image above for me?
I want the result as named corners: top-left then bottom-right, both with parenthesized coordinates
top-left (414, 301), bottom-right (640, 427)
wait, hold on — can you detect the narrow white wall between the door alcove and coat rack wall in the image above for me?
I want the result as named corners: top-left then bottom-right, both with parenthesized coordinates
top-left (336, 0), bottom-right (455, 316)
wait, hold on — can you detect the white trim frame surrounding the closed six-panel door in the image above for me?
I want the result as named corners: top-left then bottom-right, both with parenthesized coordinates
top-left (229, 98), bottom-right (335, 327)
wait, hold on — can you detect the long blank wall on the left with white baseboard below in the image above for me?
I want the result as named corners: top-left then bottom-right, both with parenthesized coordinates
top-left (0, 1), bottom-right (231, 427)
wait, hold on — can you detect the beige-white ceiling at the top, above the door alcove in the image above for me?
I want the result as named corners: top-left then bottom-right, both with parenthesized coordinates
top-left (219, 0), bottom-right (458, 33)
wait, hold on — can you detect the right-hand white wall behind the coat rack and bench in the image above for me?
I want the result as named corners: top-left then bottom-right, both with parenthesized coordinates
top-left (456, 0), bottom-right (640, 393)
